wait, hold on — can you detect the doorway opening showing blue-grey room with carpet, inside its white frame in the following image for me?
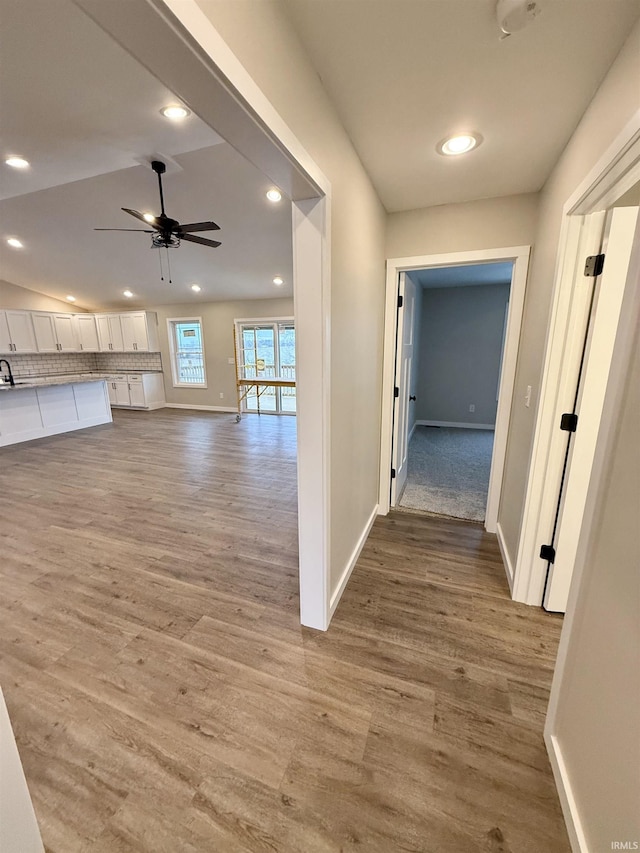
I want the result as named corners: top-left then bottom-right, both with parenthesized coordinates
top-left (391, 261), bottom-right (513, 522)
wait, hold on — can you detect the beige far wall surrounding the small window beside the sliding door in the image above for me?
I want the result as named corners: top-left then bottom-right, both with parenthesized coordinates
top-left (145, 298), bottom-right (293, 410)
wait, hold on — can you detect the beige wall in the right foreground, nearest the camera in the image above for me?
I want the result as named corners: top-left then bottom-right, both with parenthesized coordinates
top-left (550, 318), bottom-right (640, 853)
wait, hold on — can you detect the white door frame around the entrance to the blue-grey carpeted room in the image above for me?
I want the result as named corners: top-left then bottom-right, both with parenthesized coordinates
top-left (378, 246), bottom-right (531, 533)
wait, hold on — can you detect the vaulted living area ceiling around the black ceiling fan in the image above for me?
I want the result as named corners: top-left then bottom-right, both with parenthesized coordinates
top-left (0, 0), bottom-right (292, 309)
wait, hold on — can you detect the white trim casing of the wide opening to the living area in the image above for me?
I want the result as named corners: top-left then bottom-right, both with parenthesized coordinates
top-left (73, 0), bottom-right (331, 631)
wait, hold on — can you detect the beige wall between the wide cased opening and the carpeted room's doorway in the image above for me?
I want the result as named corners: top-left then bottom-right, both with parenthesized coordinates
top-left (194, 0), bottom-right (385, 591)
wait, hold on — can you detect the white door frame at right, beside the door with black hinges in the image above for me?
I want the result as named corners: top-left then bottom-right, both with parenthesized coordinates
top-left (508, 110), bottom-right (640, 607)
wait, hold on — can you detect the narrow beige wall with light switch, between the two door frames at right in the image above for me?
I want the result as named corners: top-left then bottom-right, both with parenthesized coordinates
top-left (498, 23), bottom-right (640, 564)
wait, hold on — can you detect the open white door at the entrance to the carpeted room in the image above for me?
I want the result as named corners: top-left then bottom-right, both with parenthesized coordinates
top-left (391, 272), bottom-right (416, 506)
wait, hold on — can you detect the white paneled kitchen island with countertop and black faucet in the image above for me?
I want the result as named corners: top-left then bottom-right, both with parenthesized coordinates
top-left (0, 373), bottom-right (112, 447)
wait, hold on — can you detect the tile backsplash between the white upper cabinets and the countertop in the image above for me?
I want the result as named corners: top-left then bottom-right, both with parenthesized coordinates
top-left (9, 352), bottom-right (162, 378)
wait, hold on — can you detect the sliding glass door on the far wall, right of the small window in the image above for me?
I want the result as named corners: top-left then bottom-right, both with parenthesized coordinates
top-left (236, 318), bottom-right (296, 414)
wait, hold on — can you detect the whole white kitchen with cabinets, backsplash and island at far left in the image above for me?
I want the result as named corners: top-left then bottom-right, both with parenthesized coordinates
top-left (0, 309), bottom-right (165, 447)
